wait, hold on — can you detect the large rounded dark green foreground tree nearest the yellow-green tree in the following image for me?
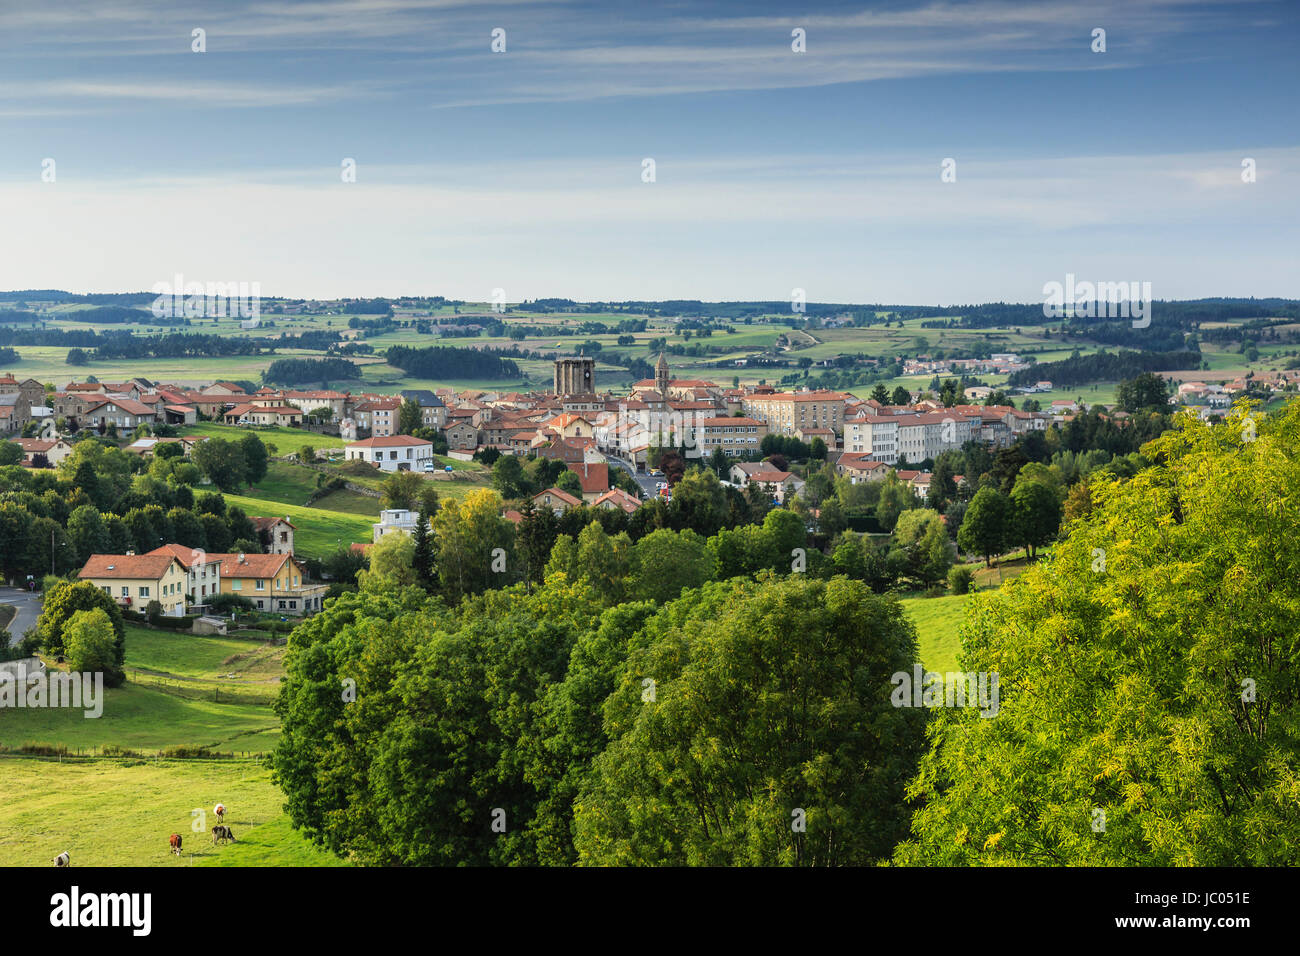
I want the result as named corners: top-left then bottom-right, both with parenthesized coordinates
top-left (575, 575), bottom-right (926, 866)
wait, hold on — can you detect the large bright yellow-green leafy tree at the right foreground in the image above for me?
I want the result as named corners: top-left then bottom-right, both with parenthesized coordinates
top-left (897, 402), bottom-right (1300, 866)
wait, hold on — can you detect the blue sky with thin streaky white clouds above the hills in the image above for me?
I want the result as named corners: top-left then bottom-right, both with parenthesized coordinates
top-left (0, 0), bottom-right (1300, 304)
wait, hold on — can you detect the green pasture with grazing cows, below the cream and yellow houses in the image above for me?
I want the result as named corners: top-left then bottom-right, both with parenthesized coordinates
top-left (0, 626), bottom-right (345, 866)
